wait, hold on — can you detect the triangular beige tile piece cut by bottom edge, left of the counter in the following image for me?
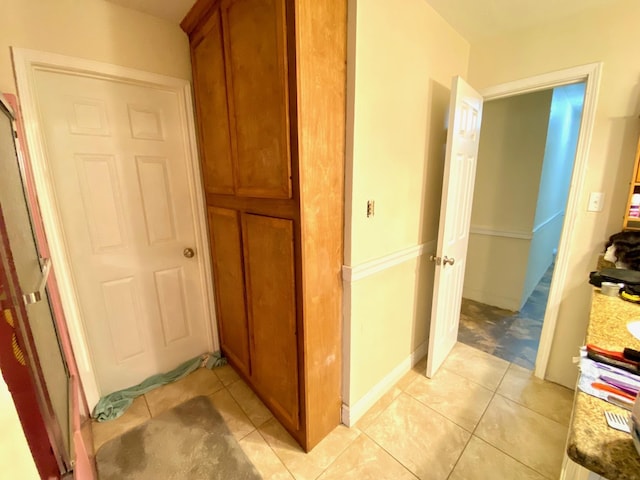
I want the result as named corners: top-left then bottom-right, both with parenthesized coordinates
top-left (449, 436), bottom-right (544, 480)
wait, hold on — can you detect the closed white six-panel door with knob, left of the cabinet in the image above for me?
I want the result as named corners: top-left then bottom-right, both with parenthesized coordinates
top-left (28, 69), bottom-right (212, 395)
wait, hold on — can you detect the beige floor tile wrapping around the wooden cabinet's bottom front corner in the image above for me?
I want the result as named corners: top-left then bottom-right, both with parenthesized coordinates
top-left (259, 418), bottom-right (360, 480)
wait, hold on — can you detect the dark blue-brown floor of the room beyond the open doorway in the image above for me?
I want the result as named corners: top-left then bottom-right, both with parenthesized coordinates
top-left (458, 264), bottom-right (554, 370)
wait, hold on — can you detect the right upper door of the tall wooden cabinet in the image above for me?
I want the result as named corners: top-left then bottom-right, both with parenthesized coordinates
top-left (221, 0), bottom-right (291, 198)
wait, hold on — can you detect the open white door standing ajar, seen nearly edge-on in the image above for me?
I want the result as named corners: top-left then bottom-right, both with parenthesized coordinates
top-left (426, 77), bottom-right (482, 378)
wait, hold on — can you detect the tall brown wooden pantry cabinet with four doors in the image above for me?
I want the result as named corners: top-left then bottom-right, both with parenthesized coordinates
top-left (181, 0), bottom-right (347, 450)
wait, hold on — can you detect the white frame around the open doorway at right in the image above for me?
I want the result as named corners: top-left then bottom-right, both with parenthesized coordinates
top-left (480, 62), bottom-right (602, 379)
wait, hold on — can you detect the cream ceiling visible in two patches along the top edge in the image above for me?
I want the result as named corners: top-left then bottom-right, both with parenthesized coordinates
top-left (108, 0), bottom-right (620, 42)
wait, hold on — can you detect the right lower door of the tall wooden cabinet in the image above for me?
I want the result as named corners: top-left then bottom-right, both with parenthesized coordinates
top-left (242, 214), bottom-right (299, 429)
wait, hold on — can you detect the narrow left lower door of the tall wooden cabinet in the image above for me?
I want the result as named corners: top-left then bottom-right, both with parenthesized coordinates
top-left (208, 207), bottom-right (251, 375)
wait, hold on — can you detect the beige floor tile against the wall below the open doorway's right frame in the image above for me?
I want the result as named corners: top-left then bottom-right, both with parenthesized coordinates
top-left (497, 365), bottom-right (574, 426)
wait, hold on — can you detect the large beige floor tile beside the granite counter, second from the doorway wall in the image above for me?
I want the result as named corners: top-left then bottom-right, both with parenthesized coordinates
top-left (474, 395), bottom-right (567, 479)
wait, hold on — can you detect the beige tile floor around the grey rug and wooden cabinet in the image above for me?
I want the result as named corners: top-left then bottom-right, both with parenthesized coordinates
top-left (94, 343), bottom-right (573, 480)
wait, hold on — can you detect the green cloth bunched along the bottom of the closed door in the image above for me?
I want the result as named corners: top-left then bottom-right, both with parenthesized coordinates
top-left (91, 351), bottom-right (227, 422)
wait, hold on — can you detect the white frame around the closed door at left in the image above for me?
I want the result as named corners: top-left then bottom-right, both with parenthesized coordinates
top-left (11, 47), bottom-right (220, 408)
